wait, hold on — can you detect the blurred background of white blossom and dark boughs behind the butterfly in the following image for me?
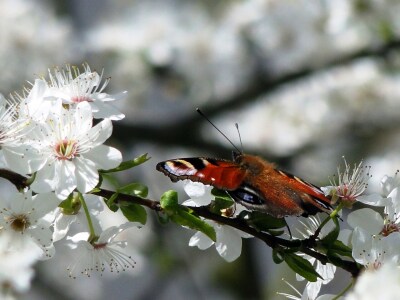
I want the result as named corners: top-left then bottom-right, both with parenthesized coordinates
top-left (0, 0), bottom-right (400, 300)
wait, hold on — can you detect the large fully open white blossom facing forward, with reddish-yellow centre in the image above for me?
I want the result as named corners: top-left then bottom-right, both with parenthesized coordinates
top-left (26, 102), bottom-right (122, 199)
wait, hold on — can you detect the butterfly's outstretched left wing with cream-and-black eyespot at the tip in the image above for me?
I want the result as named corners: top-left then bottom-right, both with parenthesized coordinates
top-left (156, 157), bottom-right (246, 191)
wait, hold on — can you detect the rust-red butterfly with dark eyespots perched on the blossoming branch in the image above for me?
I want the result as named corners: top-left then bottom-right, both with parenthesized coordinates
top-left (156, 152), bottom-right (332, 218)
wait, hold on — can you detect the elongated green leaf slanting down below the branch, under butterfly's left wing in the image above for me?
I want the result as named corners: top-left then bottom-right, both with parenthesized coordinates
top-left (170, 207), bottom-right (217, 242)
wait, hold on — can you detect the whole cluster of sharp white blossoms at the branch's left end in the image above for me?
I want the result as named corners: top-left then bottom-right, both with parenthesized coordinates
top-left (0, 64), bottom-right (135, 295)
